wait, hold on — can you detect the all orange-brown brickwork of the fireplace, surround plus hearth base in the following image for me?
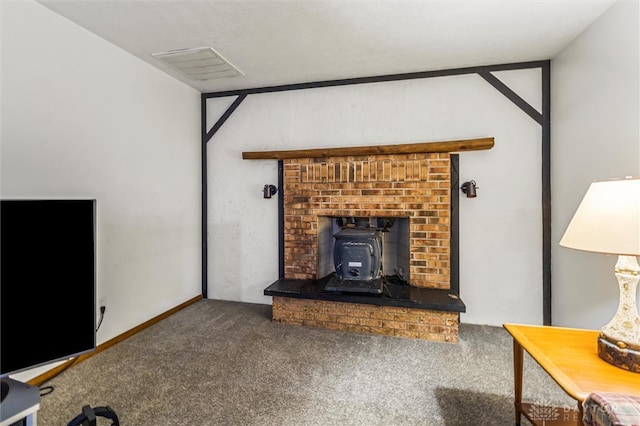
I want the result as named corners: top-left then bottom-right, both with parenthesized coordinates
top-left (272, 153), bottom-right (459, 342)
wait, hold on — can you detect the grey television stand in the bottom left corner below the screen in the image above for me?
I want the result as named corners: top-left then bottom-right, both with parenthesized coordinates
top-left (0, 378), bottom-right (40, 426)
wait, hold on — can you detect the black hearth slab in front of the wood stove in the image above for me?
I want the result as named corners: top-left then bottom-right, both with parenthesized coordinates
top-left (264, 277), bottom-right (466, 312)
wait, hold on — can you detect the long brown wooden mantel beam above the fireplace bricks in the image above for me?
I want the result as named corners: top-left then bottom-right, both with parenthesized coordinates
top-left (242, 138), bottom-right (494, 160)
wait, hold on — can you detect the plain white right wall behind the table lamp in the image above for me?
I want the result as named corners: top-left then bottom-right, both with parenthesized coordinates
top-left (551, 1), bottom-right (640, 329)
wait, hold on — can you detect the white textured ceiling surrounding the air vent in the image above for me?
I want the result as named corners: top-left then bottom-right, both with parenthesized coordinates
top-left (39, 0), bottom-right (614, 92)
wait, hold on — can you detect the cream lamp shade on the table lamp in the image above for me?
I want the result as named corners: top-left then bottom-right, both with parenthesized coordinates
top-left (560, 178), bottom-right (640, 256)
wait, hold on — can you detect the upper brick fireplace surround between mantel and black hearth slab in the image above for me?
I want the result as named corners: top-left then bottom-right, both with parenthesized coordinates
top-left (284, 153), bottom-right (451, 289)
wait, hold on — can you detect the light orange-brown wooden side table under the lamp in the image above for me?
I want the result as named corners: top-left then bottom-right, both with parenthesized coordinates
top-left (504, 324), bottom-right (640, 426)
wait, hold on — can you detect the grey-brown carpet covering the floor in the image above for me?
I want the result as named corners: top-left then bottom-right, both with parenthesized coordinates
top-left (38, 300), bottom-right (575, 426)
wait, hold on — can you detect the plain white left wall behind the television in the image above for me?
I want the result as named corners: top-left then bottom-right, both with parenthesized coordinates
top-left (0, 1), bottom-right (201, 380)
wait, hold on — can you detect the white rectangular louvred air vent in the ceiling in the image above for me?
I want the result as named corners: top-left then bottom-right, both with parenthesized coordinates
top-left (151, 47), bottom-right (244, 80)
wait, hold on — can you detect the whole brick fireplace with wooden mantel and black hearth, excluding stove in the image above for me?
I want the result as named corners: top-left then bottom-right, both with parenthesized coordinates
top-left (243, 138), bottom-right (493, 342)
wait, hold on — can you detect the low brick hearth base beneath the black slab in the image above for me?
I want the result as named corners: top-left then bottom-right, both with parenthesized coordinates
top-left (272, 297), bottom-right (459, 343)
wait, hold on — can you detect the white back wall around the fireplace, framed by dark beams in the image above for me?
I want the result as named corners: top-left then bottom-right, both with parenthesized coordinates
top-left (208, 69), bottom-right (542, 325)
